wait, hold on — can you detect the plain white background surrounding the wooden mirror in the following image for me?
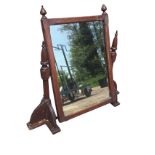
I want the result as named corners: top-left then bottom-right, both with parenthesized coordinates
top-left (0, 0), bottom-right (155, 155)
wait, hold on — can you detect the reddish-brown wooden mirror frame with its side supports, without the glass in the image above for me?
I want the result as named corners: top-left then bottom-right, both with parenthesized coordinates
top-left (27, 5), bottom-right (119, 134)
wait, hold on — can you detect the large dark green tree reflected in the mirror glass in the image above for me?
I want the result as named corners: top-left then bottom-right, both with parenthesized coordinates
top-left (61, 22), bottom-right (106, 84)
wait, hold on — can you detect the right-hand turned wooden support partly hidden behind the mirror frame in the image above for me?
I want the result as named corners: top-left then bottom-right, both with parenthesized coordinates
top-left (110, 31), bottom-right (120, 106)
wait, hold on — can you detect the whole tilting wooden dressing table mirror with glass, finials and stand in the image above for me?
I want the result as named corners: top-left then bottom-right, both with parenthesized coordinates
top-left (27, 5), bottom-right (119, 134)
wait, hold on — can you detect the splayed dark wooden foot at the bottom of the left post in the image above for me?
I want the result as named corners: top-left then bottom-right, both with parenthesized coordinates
top-left (27, 98), bottom-right (60, 134)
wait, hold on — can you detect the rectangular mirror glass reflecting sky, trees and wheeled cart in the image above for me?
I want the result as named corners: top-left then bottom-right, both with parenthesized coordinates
top-left (50, 21), bottom-right (110, 116)
